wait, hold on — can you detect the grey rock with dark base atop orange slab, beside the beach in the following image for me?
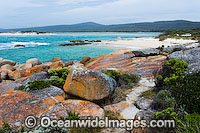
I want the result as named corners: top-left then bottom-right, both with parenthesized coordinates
top-left (132, 48), bottom-right (160, 57)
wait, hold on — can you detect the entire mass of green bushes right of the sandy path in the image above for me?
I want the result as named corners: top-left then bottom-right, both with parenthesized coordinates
top-left (154, 59), bottom-right (200, 133)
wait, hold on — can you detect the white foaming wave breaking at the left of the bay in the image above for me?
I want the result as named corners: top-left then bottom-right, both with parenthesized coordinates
top-left (0, 42), bottom-right (49, 50)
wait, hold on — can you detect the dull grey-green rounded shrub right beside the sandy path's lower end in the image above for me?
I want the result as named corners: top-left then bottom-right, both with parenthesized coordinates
top-left (153, 90), bottom-right (176, 110)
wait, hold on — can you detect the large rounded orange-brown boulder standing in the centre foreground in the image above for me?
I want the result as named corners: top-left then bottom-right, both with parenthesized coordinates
top-left (64, 63), bottom-right (117, 101)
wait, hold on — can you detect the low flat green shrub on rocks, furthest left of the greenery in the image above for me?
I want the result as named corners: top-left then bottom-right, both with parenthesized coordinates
top-left (19, 80), bottom-right (51, 91)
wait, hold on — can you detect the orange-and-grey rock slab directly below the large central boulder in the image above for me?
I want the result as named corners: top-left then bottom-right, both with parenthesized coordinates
top-left (41, 100), bottom-right (104, 119)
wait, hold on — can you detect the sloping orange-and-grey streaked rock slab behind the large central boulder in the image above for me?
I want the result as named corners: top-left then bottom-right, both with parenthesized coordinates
top-left (86, 49), bottom-right (167, 79)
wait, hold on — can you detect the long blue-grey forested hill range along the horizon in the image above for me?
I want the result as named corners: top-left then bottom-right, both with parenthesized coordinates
top-left (0, 20), bottom-right (200, 32)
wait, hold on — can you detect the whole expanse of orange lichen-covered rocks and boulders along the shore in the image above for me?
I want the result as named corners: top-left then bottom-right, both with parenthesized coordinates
top-left (0, 41), bottom-right (200, 132)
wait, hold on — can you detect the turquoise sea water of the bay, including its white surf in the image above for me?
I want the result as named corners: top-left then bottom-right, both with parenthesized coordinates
top-left (0, 33), bottom-right (160, 63)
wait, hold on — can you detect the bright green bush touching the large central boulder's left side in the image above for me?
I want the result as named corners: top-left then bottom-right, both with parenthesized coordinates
top-left (48, 68), bottom-right (70, 88)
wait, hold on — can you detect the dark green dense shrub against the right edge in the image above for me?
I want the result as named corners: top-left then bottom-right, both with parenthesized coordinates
top-left (170, 71), bottom-right (200, 113)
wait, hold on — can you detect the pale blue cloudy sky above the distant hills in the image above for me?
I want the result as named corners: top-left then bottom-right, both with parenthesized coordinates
top-left (0, 0), bottom-right (200, 29)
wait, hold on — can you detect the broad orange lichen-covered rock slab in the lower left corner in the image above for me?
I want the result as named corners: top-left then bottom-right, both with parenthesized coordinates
top-left (0, 83), bottom-right (64, 128)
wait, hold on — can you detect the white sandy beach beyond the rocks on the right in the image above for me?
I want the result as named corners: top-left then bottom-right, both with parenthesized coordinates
top-left (98, 37), bottom-right (196, 49)
